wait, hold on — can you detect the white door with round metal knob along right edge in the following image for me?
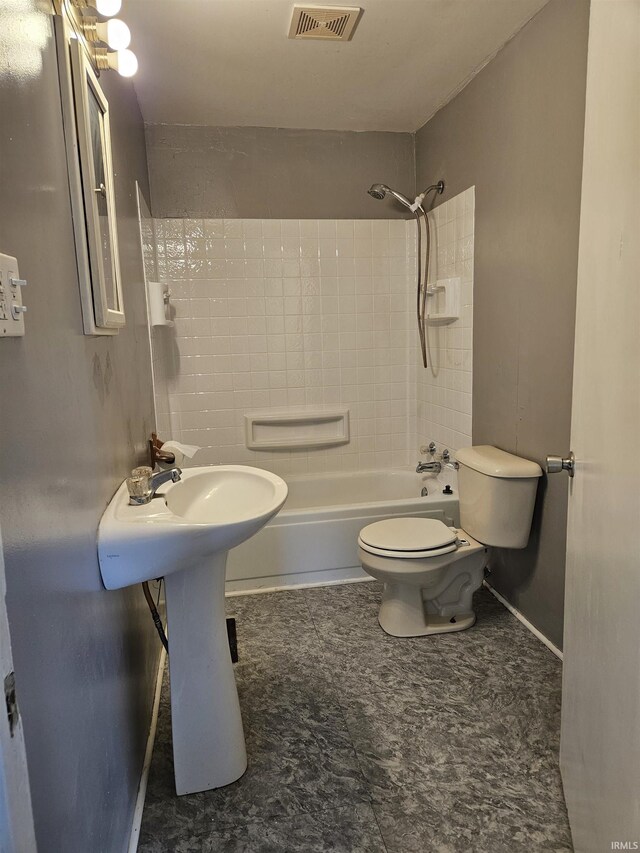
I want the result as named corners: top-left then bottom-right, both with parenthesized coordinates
top-left (561, 0), bottom-right (640, 853)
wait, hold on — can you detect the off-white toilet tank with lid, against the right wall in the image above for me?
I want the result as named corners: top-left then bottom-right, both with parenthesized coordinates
top-left (456, 445), bottom-right (542, 548)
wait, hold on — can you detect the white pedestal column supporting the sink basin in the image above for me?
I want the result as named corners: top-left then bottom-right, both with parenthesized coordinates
top-left (165, 551), bottom-right (247, 794)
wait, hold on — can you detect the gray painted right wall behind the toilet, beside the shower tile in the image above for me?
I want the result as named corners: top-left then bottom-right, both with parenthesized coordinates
top-left (416, 0), bottom-right (589, 646)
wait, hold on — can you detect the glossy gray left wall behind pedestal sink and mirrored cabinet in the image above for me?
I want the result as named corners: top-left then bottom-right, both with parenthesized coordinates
top-left (0, 0), bottom-right (160, 853)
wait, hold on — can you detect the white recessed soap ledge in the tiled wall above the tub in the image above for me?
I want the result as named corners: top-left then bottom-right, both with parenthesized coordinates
top-left (244, 409), bottom-right (349, 450)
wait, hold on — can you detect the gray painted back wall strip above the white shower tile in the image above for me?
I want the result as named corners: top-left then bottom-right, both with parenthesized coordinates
top-left (146, 125), bottom-right (415, 219)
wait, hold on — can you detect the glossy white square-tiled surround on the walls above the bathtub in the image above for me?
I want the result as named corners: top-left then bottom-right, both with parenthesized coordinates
top-left (144, 194), bottom-right (473, 474)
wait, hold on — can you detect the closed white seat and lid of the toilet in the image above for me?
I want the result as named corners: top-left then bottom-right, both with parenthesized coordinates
top-left (358, 518), bottom-right (458, 560)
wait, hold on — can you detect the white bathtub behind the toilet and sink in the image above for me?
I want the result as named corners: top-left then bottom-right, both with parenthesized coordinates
top-left (227, 469), bottom-right (459, 593)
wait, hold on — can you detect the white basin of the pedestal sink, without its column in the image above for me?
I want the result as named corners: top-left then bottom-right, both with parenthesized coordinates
top-left (98, 465), bottom-right (287, 589)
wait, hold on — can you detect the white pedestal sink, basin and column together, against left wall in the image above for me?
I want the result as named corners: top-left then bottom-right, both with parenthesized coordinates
top-left (98, 465), bottom-right (287, 794)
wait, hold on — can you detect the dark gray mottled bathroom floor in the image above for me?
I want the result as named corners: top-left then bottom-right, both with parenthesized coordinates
top-left (138, 583), bottom-right (572, 853)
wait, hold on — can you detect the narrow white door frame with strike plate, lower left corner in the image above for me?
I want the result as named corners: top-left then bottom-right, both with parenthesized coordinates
top-left (0, 531), bottom-right (36, 853)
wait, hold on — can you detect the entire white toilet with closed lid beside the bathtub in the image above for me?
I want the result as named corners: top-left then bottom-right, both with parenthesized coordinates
top-left (358, 445), bottom-right (542, 637)
